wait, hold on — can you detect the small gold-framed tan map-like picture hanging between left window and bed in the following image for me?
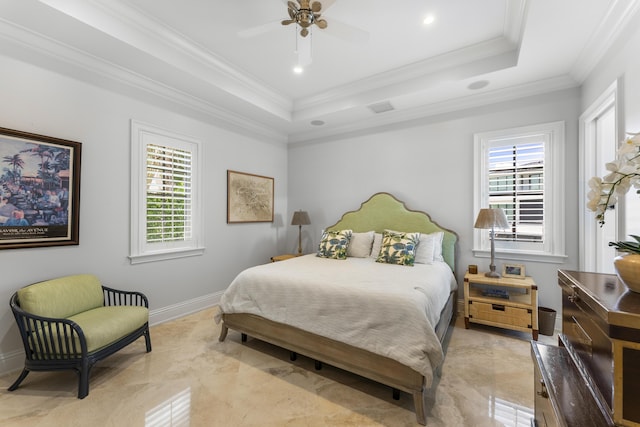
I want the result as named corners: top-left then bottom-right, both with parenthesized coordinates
top-left (227, 170), bottom-right (274, 224)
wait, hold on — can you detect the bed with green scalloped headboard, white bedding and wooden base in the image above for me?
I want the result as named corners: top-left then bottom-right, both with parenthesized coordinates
top-left (216, 193), bottom-right (457, 425)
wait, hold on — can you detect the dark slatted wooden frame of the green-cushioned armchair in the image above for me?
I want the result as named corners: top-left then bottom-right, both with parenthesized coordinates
top-left (8, 286), bottom-right (151, 399)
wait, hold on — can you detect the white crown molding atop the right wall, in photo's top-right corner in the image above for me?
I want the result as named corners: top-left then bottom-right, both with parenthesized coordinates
top-left (570, 0), bottom-right (640, 83)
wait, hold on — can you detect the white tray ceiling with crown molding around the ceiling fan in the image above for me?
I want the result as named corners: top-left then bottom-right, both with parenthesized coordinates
top-left (0, 0), bottom-right (640, 142)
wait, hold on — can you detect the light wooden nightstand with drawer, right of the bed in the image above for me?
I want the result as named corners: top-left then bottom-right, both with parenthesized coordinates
top-left (464, 272), bottom-right (538, 340)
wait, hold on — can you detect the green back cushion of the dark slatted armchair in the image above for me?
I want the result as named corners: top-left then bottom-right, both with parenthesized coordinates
top-left (18, 274), bottom-right (104, 318)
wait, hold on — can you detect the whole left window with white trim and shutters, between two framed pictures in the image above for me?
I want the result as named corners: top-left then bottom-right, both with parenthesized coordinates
top-left (129, 121), bottom-right (204, 264)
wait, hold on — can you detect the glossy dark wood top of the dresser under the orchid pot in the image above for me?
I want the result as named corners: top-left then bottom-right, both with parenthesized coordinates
top-left (558, 270), bottom-right (640, 330)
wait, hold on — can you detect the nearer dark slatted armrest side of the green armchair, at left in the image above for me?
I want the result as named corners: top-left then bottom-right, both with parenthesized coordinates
top-left (10, 294), bottom-right (87, 360)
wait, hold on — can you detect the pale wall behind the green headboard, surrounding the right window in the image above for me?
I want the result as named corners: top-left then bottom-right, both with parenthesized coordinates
top-left (288, 89), bottom-right (580, 320)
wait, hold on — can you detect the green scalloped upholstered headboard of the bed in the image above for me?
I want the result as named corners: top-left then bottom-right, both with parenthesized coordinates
top-left (327, 193), bottom-right (458, 272)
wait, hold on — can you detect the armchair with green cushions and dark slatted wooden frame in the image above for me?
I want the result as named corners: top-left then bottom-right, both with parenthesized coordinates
top-left (9, 274), bottom-right (151, 399)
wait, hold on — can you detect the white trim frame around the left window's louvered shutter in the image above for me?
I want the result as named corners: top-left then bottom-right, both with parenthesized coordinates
top-left (129, 120), bottom-right (204, 264)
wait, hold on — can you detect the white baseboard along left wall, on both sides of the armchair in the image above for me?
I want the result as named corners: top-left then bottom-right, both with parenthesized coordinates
top-left (0, 291), bottom-right (223, 375)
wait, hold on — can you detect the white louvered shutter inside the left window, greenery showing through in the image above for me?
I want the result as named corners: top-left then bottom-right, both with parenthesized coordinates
top-left (146, 144), bottom-right (193, 243)
